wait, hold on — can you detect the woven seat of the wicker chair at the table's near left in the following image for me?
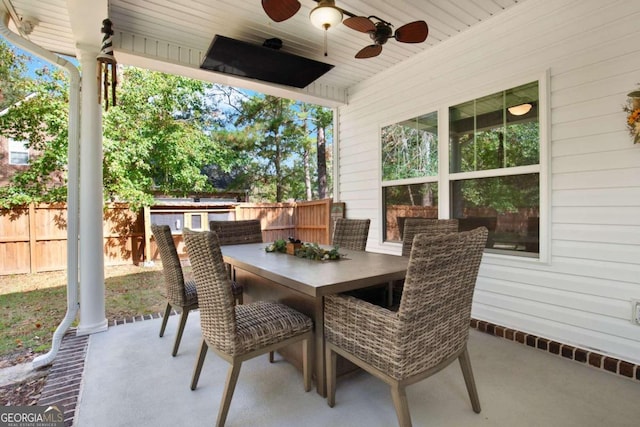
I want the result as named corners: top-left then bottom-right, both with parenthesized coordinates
top-left (235, 301), bottom-right (313, 355)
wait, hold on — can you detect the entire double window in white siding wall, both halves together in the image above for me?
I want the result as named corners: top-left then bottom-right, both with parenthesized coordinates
top-left (380, 81), bottom-right (546, 257)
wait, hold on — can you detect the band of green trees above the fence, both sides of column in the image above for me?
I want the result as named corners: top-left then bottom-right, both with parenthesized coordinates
top-left (0, 41), bottom-right (331, 209)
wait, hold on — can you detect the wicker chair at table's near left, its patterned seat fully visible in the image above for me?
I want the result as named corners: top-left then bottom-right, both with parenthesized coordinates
top-left (184, 229), bottom-right (313, 427)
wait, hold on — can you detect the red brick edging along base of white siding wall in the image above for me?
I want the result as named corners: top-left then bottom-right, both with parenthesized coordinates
top-left (471, 319), bottom-right (640, 381)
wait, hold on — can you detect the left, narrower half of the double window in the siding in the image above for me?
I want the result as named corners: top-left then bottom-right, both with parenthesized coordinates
top-left (380, 112), bottom-right (438, 241)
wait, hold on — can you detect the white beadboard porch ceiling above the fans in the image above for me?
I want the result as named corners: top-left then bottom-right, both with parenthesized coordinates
top-left (0, 0), bottom-right (525, 103)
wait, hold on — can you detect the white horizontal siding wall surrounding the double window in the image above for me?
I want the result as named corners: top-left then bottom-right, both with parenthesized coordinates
top-left (337, 0), bottom-right (640, 363)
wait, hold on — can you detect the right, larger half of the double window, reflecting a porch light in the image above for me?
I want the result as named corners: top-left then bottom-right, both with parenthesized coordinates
top-left (449, 82), bottom-right (540, 256)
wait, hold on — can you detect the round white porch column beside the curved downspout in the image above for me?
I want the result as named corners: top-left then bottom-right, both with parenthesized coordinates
top-left (77, 46), bottom-right (107, 335)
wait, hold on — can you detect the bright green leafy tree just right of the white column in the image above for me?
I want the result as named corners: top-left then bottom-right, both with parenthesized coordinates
top-left (103, 67), bottom-right (221, 206)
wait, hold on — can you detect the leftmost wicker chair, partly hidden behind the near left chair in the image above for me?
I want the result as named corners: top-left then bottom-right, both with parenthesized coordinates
top-left (151, 224), bottom-right (198, 356)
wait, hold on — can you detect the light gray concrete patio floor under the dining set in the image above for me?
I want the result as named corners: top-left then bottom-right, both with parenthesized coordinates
top-left (74, 312), bottom-right (640, 427)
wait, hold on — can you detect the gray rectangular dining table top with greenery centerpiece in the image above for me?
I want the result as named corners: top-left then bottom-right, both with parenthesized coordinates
top-left (221, 243), bottom-right (409, 297)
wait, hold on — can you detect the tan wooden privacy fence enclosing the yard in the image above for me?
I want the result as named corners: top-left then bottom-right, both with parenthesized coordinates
top-left (0, 199), bottom-right (333, 275)
